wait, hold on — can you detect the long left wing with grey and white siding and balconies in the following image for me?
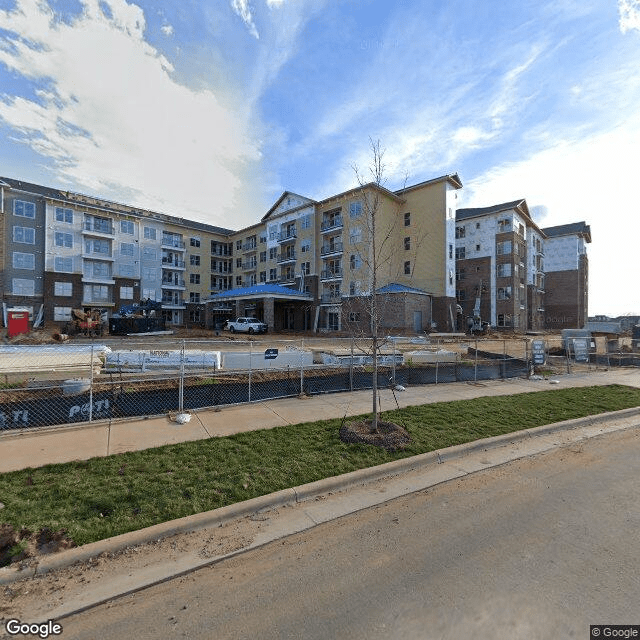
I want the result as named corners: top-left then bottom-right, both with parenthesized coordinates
top-left (0, 178), bottom-right (232, 325)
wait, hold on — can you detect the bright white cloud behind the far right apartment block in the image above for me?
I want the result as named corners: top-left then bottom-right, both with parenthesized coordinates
top-left (460, 119), bottom-right (640, 315)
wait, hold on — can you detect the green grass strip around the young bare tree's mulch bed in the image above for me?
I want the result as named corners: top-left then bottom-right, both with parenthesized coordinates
top-left (0, 385), bottom-right (640, 545)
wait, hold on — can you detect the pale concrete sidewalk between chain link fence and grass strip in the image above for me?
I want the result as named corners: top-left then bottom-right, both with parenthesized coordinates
top-left (0, 368), bottom-right (640, 473)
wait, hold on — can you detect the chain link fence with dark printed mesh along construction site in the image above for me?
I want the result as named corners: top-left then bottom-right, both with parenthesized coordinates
top-left (0, 336), bottom-right (640, 430)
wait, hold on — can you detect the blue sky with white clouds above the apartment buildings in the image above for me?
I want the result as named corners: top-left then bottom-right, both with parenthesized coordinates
top-left (0, 0), bottom-right (640, 316)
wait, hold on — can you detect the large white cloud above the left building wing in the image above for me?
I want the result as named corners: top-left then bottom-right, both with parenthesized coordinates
top-left (0, 0), bottom-right (260, 226)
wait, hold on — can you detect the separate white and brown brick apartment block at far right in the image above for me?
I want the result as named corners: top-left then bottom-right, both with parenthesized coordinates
top-left (455, 199), bottom-right (591, 331)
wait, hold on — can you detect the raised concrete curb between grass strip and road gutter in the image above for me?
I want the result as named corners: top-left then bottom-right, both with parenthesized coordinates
top-left (0, 407), bottom-right (640, 585)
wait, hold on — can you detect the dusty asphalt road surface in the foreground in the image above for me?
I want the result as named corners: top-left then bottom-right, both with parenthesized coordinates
top-left (60, 430), bottom-right (640, 640)
